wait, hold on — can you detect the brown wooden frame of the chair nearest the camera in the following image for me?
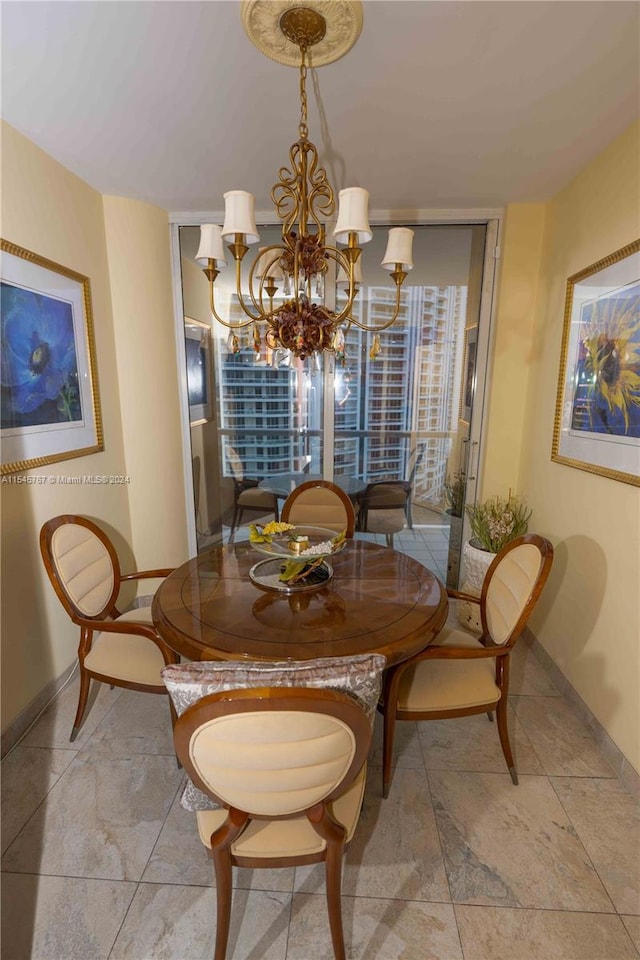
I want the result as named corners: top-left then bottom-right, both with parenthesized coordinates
top-left (174, 687), bottom-right (371, 960)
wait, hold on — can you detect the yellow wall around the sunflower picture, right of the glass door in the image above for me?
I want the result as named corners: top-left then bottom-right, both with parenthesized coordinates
top-left (485, 126), bottom-right (640, 772)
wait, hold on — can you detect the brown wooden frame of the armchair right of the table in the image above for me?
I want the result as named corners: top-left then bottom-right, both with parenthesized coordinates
top-left (378, 533), bottom-right (553, 797)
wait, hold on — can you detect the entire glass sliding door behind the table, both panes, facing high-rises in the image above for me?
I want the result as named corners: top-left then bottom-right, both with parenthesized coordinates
top-left (180, 225), bottom-right (492, 585)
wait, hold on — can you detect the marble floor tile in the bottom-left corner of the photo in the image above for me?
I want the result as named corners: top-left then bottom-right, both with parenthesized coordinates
top-left (2, 873), bottom-right (136, 960)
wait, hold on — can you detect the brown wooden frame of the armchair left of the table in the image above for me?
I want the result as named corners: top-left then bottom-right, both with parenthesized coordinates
top-left (40, 514), bottom-right (180, 742)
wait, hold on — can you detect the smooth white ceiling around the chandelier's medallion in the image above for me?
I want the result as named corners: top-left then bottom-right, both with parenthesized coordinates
top-left (1, 0), bottom-right (640, 212)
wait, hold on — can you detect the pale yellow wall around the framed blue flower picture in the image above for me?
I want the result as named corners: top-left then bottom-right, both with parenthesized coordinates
top-left (0, 124), bottom-right (131, 730)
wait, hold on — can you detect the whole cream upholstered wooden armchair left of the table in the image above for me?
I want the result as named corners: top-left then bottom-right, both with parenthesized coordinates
top-left (40, 514), bottom-right (179, 741)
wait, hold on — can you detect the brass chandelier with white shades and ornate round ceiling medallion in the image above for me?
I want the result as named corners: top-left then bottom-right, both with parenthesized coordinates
top-left (196, 0), bottom-right (413, 359)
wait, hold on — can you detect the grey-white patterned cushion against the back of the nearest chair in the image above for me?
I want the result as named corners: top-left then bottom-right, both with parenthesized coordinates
top-left (162, 653), bottom-right (386, 811)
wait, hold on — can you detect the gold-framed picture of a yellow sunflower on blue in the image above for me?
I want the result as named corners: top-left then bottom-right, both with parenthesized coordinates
top-left (551, 240), bottom-right (640, 486)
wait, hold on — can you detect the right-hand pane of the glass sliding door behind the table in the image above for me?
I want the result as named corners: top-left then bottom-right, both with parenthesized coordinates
top-left (333, 225), bottom-right (485, 586)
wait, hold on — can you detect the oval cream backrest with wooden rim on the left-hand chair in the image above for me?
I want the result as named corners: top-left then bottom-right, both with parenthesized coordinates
top-left (40, 514), bottom-right (120, 620)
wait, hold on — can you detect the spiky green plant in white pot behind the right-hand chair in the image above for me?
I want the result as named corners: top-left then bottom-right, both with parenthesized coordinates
top-left (458, 492), bottom-right (532, 631)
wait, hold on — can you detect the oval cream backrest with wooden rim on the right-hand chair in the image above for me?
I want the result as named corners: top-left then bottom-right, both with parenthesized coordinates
top-left (480, 533), bottom-right (553, 646)
